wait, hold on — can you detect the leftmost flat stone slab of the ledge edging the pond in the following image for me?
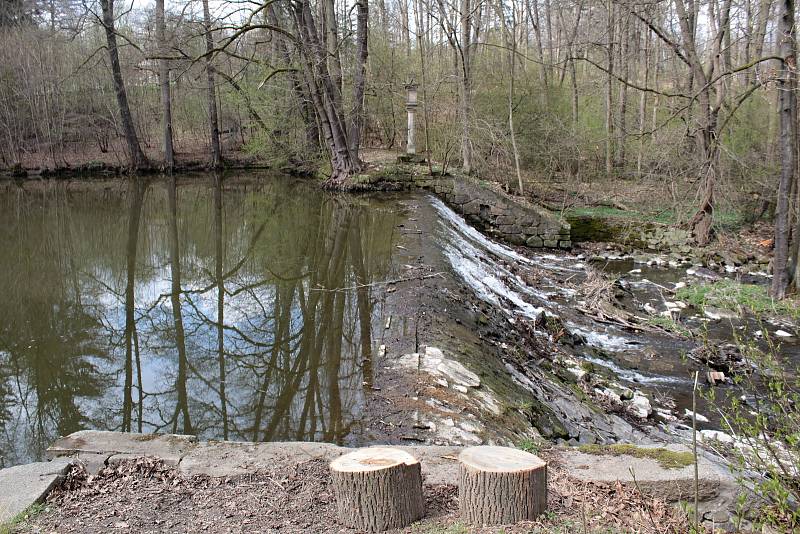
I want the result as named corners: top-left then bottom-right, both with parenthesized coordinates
top-left (47, 430), bottom-right (197, 465)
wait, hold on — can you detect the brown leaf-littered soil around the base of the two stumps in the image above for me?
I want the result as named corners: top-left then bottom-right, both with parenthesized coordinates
top-left (10, 455), bottom-right (688, 534)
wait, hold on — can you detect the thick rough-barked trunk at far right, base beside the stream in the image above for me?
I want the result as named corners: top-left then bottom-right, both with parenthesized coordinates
top-left (771, 0), bottom-right (798, 299)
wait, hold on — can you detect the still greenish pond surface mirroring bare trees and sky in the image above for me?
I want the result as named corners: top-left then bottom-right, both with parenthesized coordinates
top-left (0, 176), bottom-right (401, 464)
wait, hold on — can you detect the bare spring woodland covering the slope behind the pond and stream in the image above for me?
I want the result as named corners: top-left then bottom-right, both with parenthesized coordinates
top-left (0, 0), bottom-right (800, 296)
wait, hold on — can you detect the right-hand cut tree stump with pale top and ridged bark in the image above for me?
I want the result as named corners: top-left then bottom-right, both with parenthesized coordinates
top-left (458, 446), bottom-right (547, 525)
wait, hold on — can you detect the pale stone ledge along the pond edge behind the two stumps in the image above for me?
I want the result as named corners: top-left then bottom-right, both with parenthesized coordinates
top-left (45, 431), bottom-right (739, 511)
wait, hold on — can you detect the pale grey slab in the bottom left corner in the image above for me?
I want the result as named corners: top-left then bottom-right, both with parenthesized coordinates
top-left (0, 458), bottom-right (72, 525)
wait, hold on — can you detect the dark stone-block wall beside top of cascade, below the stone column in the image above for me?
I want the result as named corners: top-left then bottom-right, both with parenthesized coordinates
top-left (351, 166), bottom-right (572, 249)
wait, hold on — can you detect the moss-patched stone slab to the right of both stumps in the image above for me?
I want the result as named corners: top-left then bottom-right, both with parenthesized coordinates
top-left (559, 445), bottom-right (737, 505)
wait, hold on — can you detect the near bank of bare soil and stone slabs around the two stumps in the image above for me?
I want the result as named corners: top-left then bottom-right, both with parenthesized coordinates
top-left (0, 432), bottom-right (737, 534)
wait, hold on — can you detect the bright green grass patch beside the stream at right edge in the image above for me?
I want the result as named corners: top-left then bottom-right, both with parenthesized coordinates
top-left (675, 279), bottom-right (800, 319)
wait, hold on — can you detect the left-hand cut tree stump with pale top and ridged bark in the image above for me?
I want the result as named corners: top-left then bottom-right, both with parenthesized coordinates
top-left (330, 447), bottom-right (425, 532)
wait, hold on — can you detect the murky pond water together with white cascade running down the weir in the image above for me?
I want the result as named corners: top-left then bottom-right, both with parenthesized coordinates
top-left (0, 174), bottom-right (800, 467)
